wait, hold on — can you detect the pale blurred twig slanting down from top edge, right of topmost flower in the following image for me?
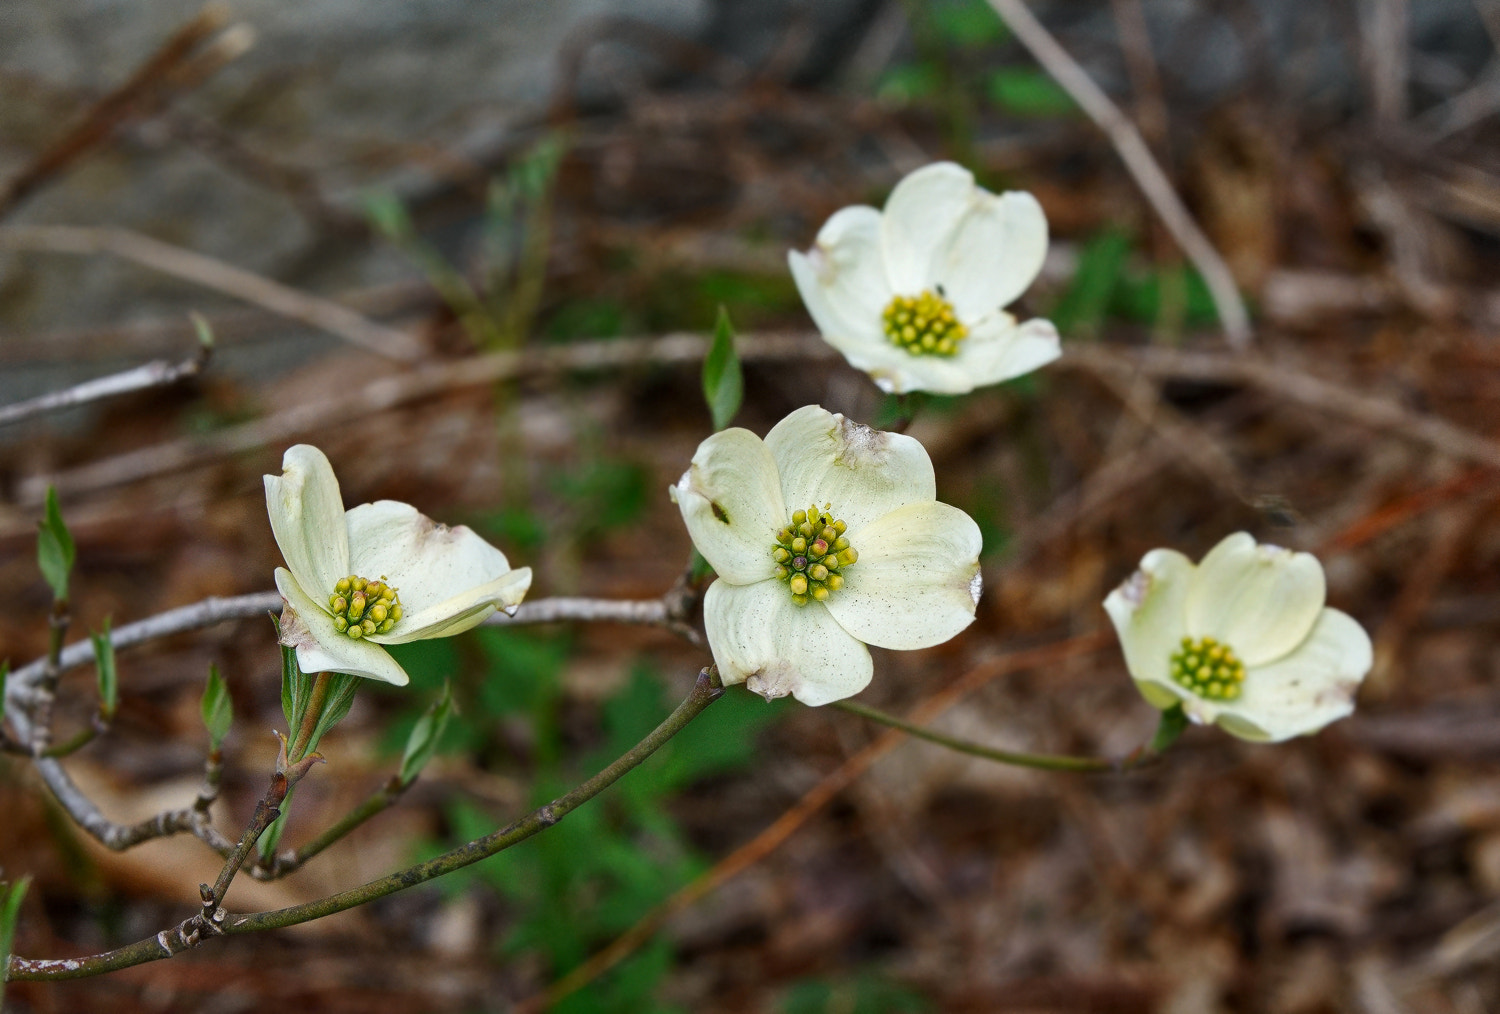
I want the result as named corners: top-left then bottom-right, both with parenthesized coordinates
top-left (989, 0), bottom-right (1251, 350)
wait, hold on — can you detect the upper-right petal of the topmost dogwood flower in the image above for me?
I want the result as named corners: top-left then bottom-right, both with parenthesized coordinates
top-left (935, 189), bottom-right (1047, 321)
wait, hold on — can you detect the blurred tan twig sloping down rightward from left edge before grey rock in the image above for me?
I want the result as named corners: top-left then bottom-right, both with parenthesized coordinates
top-left (0, 225), bottom-right (422, 362)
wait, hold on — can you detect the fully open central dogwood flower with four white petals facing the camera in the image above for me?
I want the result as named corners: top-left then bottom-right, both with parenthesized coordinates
top-left (672, 405), bottom-right (981, 705)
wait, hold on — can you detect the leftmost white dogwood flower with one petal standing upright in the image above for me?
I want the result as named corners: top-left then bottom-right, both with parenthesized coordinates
top-left (266, 444), bottom-right (531, 686)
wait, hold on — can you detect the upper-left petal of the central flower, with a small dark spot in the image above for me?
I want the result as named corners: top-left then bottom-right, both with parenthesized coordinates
top-left (671, 428), bottom-right (791, 585)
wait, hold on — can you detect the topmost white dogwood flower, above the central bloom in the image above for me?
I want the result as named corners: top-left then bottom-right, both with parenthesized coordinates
top-left (788, 162), bottom-right (1062, 395)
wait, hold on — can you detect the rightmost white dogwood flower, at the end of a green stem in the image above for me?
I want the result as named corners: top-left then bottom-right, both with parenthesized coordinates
top-left (1104, 533), bottom-right (1373, 743)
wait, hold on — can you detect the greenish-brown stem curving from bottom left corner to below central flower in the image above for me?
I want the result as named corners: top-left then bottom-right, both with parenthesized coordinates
top-left (6, 668), bottom-right (725, 983)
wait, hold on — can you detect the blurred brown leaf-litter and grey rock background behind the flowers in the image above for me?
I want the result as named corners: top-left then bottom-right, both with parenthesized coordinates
top-left (0, 0), bottom-right (1500, 1014)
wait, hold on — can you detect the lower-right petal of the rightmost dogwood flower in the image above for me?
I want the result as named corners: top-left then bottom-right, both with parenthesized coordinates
top-left (1217, 609), bottom-right (1374, 743)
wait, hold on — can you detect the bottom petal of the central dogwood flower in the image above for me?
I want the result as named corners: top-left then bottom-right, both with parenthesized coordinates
top-left (704, 579), bottom-right (875, 707)
